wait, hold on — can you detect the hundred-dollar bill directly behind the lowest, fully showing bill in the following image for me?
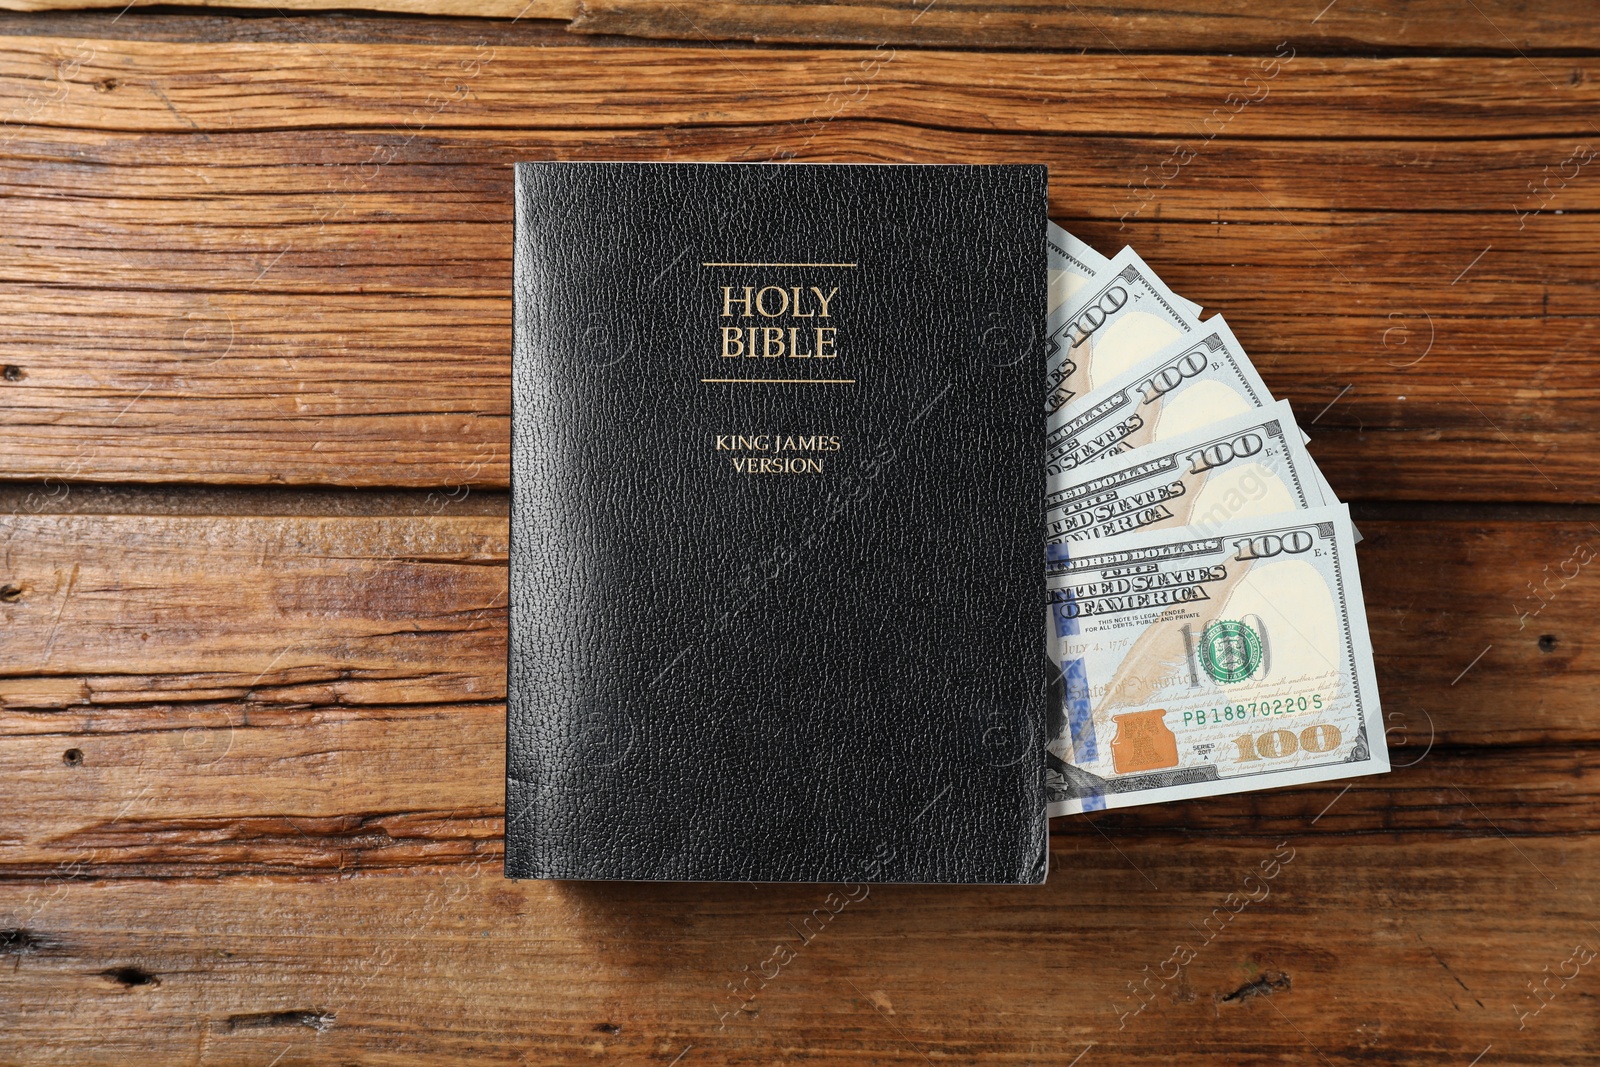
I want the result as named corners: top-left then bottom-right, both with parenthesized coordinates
top-left (1045, 400), bottom-right (1333, 544)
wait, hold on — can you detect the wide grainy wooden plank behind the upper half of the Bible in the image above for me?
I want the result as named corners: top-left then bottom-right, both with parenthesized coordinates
top-left (0, 37), bottom-right (1600, 502)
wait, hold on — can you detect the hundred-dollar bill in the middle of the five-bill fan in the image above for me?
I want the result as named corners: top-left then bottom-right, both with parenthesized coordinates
top-left (1045, 315), bottom-right (1272, 475)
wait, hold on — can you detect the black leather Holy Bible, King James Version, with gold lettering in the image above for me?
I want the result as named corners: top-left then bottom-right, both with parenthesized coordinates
top-left (506, 163), bottom-right (1046, 883)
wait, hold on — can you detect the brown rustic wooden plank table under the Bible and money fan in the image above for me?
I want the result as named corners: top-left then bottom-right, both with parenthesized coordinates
top-left (0, 0), bottom-right (1600, 1067)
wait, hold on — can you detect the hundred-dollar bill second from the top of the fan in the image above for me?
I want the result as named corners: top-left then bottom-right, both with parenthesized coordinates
top-left (1045, 248), bottom-right (1200, 414)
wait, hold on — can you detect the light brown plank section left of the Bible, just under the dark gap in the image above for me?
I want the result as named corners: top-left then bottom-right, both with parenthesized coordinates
top-left (0, 514), bottom-right (506, 710)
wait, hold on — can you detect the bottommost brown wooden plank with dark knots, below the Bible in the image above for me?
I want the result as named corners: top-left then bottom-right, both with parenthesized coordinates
top-left (0, 838), bottom-right (1600, 1067)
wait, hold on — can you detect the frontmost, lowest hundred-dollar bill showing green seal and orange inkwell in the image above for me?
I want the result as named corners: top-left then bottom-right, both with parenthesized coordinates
top-left (1046, 504), bottom-right (1389, 816)
